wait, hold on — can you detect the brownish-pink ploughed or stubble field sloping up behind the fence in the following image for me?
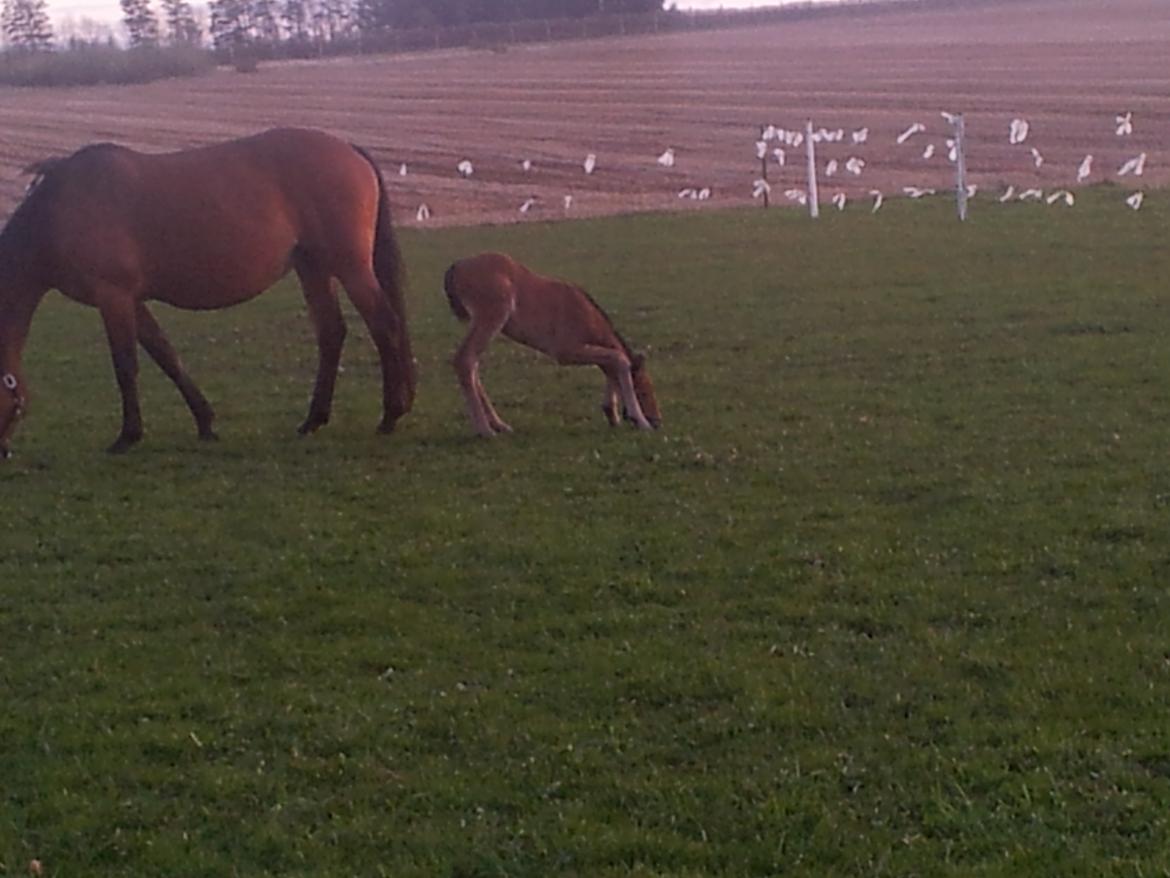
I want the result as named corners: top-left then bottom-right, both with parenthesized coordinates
top-left (0, 0), bottom-right (1170, 225)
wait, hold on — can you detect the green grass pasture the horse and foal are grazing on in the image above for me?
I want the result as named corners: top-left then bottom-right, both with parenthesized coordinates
top-left (0, 194), bottom-right (1170, 878)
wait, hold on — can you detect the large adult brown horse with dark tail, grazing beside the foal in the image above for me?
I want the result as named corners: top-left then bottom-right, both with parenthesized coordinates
top-left (0, 129), bottom-right (414, 457)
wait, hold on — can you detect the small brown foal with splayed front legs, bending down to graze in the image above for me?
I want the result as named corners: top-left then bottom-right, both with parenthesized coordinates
top-left (443, 253), bottom-right (662, 435)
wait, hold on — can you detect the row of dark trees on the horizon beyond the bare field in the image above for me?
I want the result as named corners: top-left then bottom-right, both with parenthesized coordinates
top-left (0, 0), bottom-right (663, 52)
